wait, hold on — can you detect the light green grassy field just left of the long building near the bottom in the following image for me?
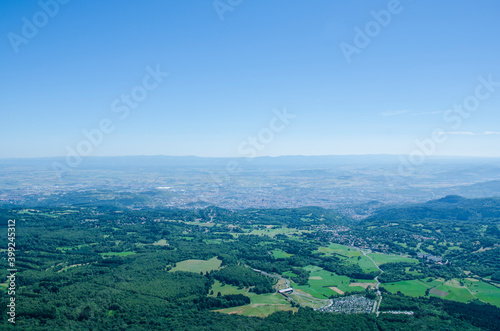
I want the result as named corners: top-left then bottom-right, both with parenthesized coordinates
top-left (211, 281), bottom-right (298, 317)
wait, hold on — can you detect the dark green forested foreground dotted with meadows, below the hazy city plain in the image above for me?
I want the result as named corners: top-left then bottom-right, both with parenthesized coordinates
top-left (0, 200), bottom-right (500, 330)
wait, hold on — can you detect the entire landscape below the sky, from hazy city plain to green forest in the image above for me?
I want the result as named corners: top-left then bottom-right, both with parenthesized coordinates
top-left (0, 156), bottom-right (500, 330)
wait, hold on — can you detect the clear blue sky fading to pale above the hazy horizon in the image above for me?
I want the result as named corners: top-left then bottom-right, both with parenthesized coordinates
top-left (0, 0), bottom-right (500, 158)
